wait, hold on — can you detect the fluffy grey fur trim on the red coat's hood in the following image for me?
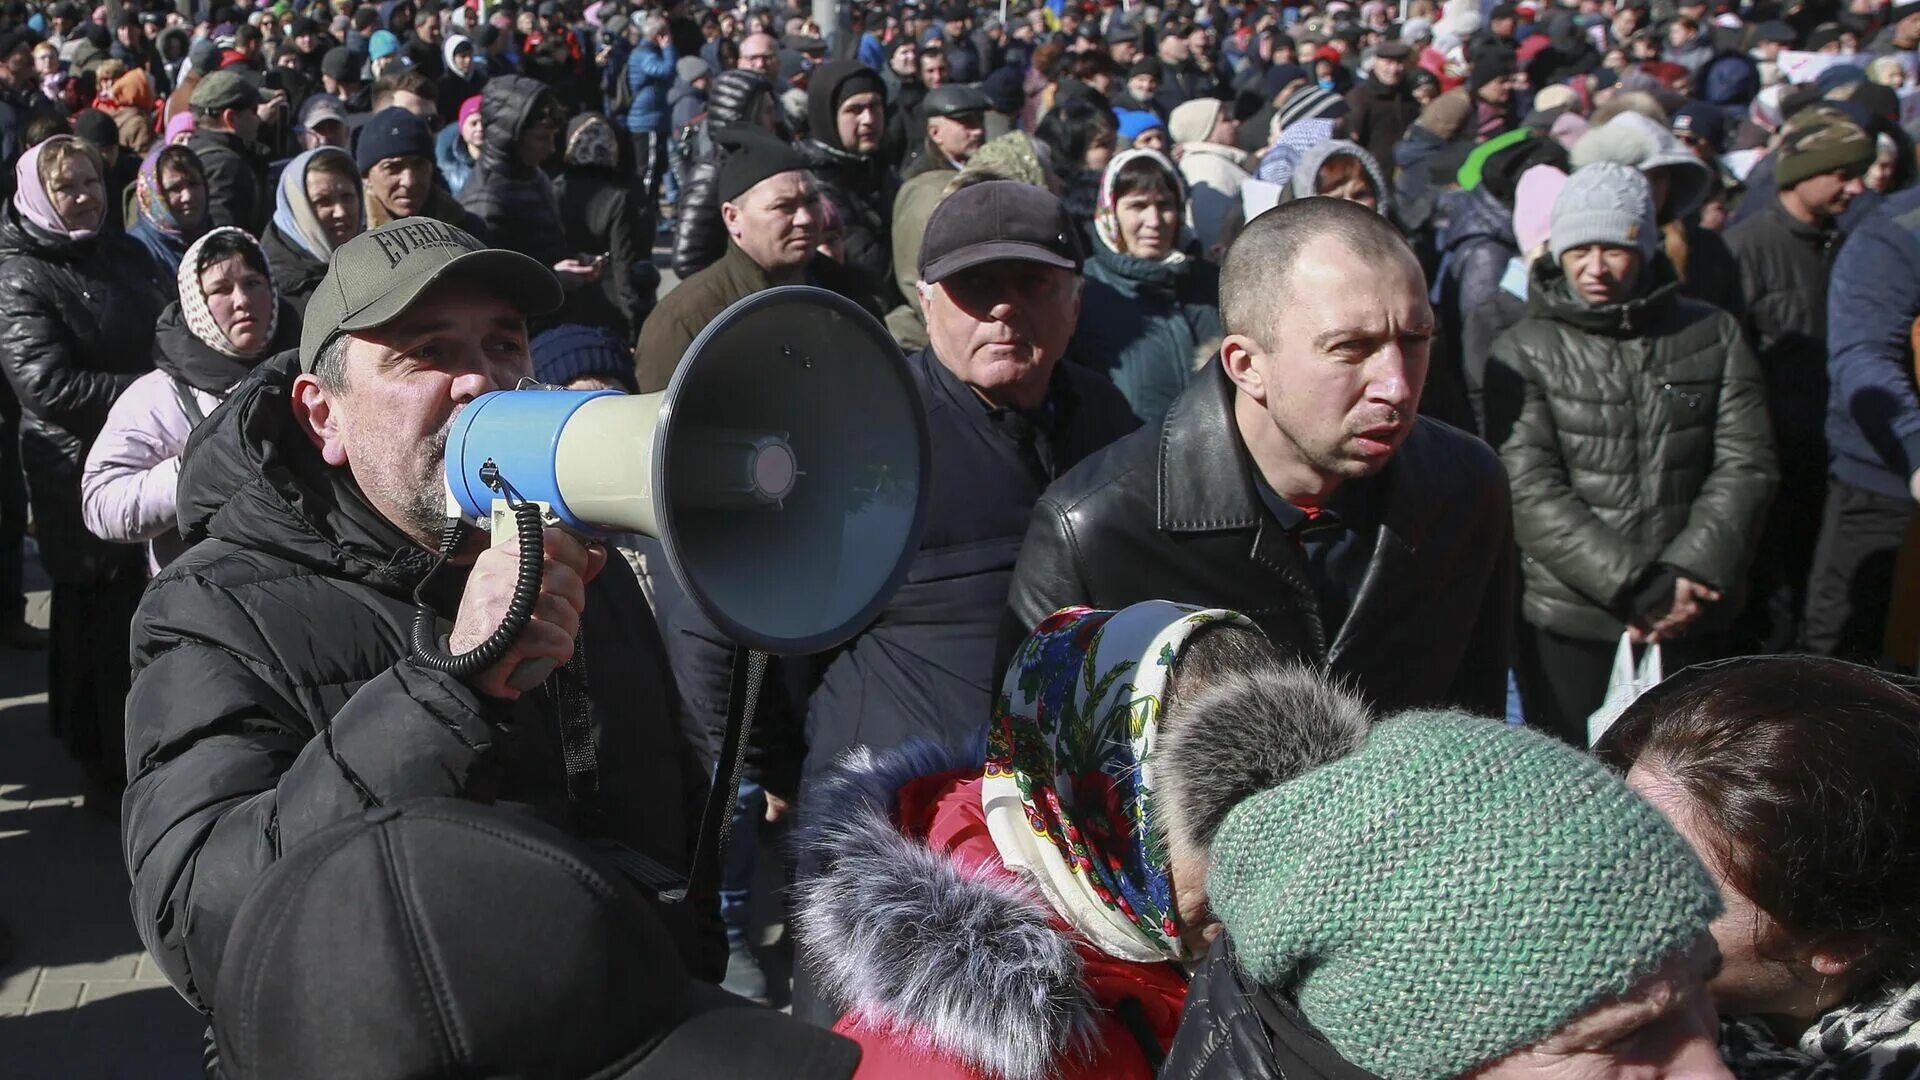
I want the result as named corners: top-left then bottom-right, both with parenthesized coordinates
top-left (795, 744), bottom-right (1096, 1080)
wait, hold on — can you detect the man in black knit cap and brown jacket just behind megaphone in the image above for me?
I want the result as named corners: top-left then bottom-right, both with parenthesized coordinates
top-left (634, 127), bottom-right (877, 386)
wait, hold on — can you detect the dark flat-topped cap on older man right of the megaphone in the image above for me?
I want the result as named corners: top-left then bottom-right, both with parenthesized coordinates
top-left (920, 181), bottom-right (1081, 282)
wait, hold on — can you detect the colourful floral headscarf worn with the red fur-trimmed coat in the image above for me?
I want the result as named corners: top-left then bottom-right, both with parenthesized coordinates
top-left (981, 600), bottom-right (1254, 963)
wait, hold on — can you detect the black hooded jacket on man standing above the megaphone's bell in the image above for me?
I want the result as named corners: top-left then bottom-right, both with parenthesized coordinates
top-left (801, 60), bottom-right (893, 307)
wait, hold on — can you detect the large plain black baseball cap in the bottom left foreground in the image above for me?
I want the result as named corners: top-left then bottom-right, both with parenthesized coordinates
top-left (213, 799), bottom-right (860, 1080)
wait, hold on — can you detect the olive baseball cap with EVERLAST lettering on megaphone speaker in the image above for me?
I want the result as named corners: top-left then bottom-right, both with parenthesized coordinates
top-left (300, 217), bottom-right (564, 371)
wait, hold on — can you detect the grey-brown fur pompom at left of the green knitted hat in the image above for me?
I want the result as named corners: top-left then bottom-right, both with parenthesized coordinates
top-left (1154, 663), bottom-right (1373, 865)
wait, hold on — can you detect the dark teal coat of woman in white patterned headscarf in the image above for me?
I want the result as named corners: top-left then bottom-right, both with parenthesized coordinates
top-left (1068, 238), bottom-right (1221, 425)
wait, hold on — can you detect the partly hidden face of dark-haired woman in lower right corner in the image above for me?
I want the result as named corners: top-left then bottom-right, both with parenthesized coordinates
top-left (1626, 761), bottom-right (1853, 1022)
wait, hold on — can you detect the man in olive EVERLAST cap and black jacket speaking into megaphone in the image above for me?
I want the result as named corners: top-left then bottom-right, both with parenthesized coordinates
top-left (123, 219), bottom-right (724, 1014)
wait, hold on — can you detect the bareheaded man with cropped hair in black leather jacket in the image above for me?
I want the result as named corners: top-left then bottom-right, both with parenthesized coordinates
top-left (1000, 198), bottom-right (1513, 713)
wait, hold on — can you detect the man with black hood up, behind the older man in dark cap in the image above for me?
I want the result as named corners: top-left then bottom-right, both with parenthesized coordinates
top-left (801, 60), bottom-right (898, 307)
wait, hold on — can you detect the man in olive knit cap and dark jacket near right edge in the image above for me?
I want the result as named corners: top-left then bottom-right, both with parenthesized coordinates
top-left (1726, 117), bottom-right (1874, 653)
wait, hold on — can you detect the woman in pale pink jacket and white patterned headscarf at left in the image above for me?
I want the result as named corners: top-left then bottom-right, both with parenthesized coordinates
top-left (81, 229), bottom-right (300, 571)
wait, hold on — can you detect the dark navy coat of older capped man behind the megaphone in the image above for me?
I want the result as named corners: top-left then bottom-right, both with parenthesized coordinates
top-left (662, 350), bottom-right (1139, 796)
